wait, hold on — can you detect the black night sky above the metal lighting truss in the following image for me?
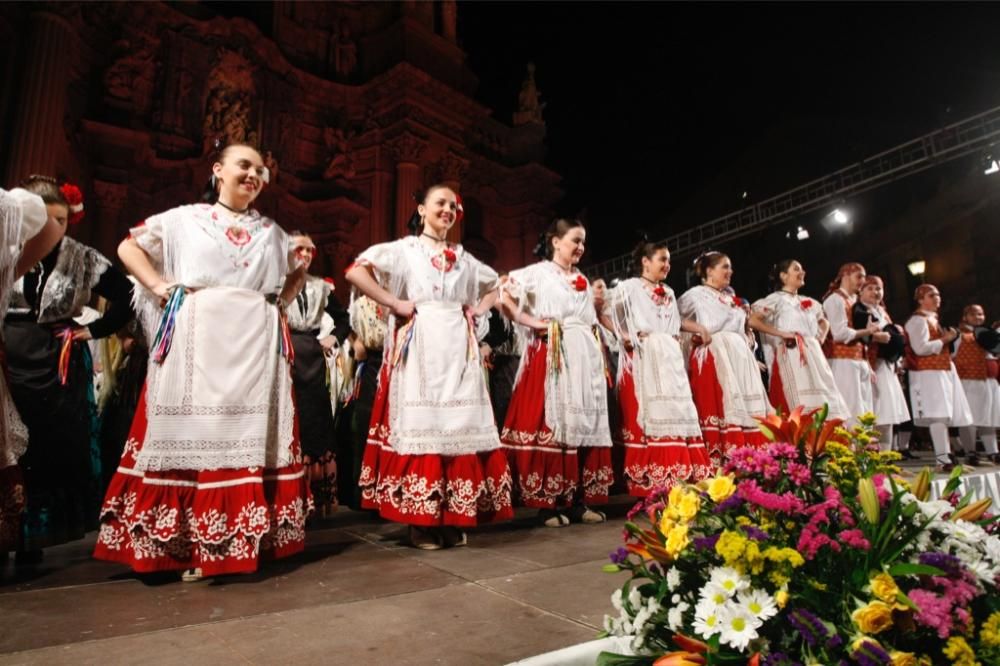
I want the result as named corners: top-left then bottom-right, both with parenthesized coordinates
top-left (459, 2), bottom-right (1000, 260)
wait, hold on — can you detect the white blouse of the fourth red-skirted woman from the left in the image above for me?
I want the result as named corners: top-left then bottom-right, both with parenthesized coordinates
top-left (605, 278), bottom-right (681, 338)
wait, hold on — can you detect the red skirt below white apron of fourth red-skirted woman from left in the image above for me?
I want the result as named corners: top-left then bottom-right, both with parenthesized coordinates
top-left (618, 358), bottom-right (712, 497)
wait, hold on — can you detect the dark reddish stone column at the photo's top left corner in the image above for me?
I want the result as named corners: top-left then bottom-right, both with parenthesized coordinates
top-left (7, 11), bottom-right (76, 183)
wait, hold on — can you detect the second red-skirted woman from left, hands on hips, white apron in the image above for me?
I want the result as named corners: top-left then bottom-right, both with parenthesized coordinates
top-left (347, 185), bottom-right (513, 550)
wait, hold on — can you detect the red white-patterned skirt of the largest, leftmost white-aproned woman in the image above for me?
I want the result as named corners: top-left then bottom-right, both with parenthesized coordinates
top-left (94, 387), bottom-right (312, 576)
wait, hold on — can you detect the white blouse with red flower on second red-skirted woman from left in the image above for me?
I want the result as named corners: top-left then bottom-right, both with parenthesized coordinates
top-left (355, 236), bottom-right (498, 306)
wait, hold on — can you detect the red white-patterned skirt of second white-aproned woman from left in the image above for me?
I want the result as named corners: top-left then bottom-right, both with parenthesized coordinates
top-left (358, 363), bottom-right (514, 527)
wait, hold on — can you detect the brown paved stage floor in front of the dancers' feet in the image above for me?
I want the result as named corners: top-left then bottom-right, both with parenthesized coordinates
top-left (0, 497), bottom-right (631, 666)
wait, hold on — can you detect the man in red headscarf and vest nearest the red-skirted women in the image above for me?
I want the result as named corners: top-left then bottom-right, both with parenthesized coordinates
top-left (823, 262), bottom-right (880, 424)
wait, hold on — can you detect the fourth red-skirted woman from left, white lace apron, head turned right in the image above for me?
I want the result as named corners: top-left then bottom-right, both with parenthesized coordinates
top-left (605, 240), bottom-right (711, 497)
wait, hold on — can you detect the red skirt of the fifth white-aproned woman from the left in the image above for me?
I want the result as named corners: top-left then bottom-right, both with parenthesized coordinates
top-left (689, 348), bottom-right (767, 467)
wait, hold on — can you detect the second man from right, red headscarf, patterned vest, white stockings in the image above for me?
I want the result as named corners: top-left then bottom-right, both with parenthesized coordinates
top-left (906, 284), bottom-right (973, 472)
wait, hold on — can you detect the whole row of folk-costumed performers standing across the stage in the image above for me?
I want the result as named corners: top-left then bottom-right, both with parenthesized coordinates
top-left (0, 145), bottom-right (1000, 579)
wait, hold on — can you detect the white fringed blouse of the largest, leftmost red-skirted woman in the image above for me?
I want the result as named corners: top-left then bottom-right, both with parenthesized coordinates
top-left (131, 204), bottom-right (296, 294)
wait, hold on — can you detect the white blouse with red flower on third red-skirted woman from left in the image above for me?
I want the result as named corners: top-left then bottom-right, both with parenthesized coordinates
top-left (504, 261), bottom-right (597, 325)
